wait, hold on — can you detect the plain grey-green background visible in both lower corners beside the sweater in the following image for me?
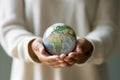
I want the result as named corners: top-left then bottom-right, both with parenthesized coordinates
top-left (0, 46), bottom-right (120, 80)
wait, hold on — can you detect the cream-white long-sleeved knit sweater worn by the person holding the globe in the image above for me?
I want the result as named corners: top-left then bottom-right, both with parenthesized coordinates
top-left (0, 0), bottom-right (119, 80)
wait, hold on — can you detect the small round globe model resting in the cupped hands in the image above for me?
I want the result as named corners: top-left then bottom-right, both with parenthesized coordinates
top-left (43, 23), bottom-right (77, 55)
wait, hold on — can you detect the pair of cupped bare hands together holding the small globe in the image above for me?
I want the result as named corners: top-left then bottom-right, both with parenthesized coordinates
top-left (29, 37), bottom-right (93, 68)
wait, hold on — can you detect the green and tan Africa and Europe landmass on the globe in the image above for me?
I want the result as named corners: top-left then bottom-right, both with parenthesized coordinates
top-left (48, 25), bottom-right (75, 52)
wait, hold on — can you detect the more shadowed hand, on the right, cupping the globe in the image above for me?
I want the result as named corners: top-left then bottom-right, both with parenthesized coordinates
top-left (60, 37), bottom-right (93, 66)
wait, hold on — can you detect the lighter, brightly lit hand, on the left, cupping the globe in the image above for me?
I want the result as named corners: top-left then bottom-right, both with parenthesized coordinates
top-left (32, 38), bottom-right (68, 68)
